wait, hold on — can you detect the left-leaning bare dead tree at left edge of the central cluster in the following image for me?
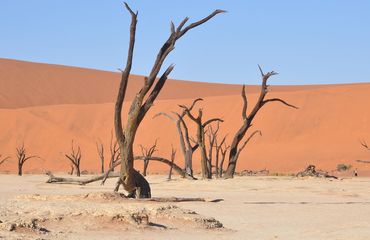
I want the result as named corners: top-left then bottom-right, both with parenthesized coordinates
top-left (154, 98), bottom-right (203, 176)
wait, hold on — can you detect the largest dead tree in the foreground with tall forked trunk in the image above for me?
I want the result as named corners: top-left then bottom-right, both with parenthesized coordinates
top-left (114, 3), bottom-right (224, 198)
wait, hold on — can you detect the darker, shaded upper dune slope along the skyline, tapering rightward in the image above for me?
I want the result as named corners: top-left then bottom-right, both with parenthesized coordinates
top-left (0, 58), bottom-right (344, 108)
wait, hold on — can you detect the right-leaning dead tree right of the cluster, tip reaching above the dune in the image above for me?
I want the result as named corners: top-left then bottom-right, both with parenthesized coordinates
top-left (224, 66), bottom-right (297, 178)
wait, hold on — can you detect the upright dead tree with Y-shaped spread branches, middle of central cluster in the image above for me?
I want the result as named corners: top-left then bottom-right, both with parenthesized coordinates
top-left (179, 100), bottom-right (223, 179)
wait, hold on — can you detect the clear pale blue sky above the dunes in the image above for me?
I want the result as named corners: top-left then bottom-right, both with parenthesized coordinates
top-left (0, 0), bottom-right (370, 84)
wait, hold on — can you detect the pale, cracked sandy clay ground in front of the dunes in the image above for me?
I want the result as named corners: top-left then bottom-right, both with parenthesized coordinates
top-left (0, 175), bottom-right (370, 239)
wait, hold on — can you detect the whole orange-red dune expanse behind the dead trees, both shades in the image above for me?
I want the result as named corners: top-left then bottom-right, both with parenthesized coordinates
top-left (0, 59), bottom-right (370, 175)
